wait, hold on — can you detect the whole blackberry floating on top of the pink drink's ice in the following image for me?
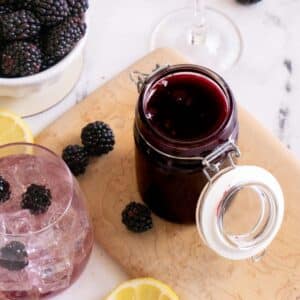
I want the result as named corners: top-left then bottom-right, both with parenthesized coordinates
top-left (21, 184), bottom-right (52, 215)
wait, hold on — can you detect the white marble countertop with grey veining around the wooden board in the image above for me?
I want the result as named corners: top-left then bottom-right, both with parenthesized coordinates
top-left (27, 0), bottom-right (300, 300)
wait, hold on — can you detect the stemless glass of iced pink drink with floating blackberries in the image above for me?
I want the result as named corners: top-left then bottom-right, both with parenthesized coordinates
top-left (0, 144), bottom-right (93, 300)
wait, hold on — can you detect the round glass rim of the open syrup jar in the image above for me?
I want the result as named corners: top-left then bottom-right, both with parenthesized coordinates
top-left (136, 64), bottom-right (237, 157)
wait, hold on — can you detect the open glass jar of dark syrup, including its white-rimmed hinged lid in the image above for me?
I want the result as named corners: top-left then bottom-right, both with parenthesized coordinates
top-left (134, 65), bottom-right (284, 259)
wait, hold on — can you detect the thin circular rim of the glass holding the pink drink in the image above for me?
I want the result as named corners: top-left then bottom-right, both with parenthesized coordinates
top-left (0, 142), bottom-right (74, 237)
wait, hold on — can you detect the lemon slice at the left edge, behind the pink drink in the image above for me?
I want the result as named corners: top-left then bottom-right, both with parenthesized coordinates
top-left (0, 109), bottom-right (33, 146)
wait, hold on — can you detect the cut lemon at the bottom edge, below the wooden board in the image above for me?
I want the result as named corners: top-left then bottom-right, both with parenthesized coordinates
top-left (105, 278), bottom-right (179, 300)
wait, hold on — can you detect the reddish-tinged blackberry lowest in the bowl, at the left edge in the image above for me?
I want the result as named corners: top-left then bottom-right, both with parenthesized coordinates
top-left (0, 41), bottom-right (42, 77)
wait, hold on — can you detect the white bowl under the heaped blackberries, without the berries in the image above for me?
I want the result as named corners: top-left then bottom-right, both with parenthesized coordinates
top-left (0, 22), bottom-right (87, 117)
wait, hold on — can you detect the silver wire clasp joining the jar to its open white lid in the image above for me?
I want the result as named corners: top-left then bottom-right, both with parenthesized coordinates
top-left (202, 138), bottom-right (241, 182)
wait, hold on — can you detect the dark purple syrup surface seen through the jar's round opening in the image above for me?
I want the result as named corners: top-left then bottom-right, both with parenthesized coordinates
top-left (144, 72), bottom-right (229, 141)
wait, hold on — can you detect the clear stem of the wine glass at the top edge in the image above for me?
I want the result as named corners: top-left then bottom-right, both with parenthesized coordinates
top-left (189, 0), bottom-right (206, 45)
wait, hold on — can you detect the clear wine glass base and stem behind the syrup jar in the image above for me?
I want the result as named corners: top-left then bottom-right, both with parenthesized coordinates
top-left (151, 0), bottom-right (242, 72)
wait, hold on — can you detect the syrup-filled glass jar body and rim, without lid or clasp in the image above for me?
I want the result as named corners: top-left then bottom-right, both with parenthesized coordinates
top-left (135, 66), bottom-right (238, 223)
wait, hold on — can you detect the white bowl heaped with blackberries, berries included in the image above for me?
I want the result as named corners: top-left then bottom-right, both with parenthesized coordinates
top-left (0, 0), bottom-right (89, 99)
